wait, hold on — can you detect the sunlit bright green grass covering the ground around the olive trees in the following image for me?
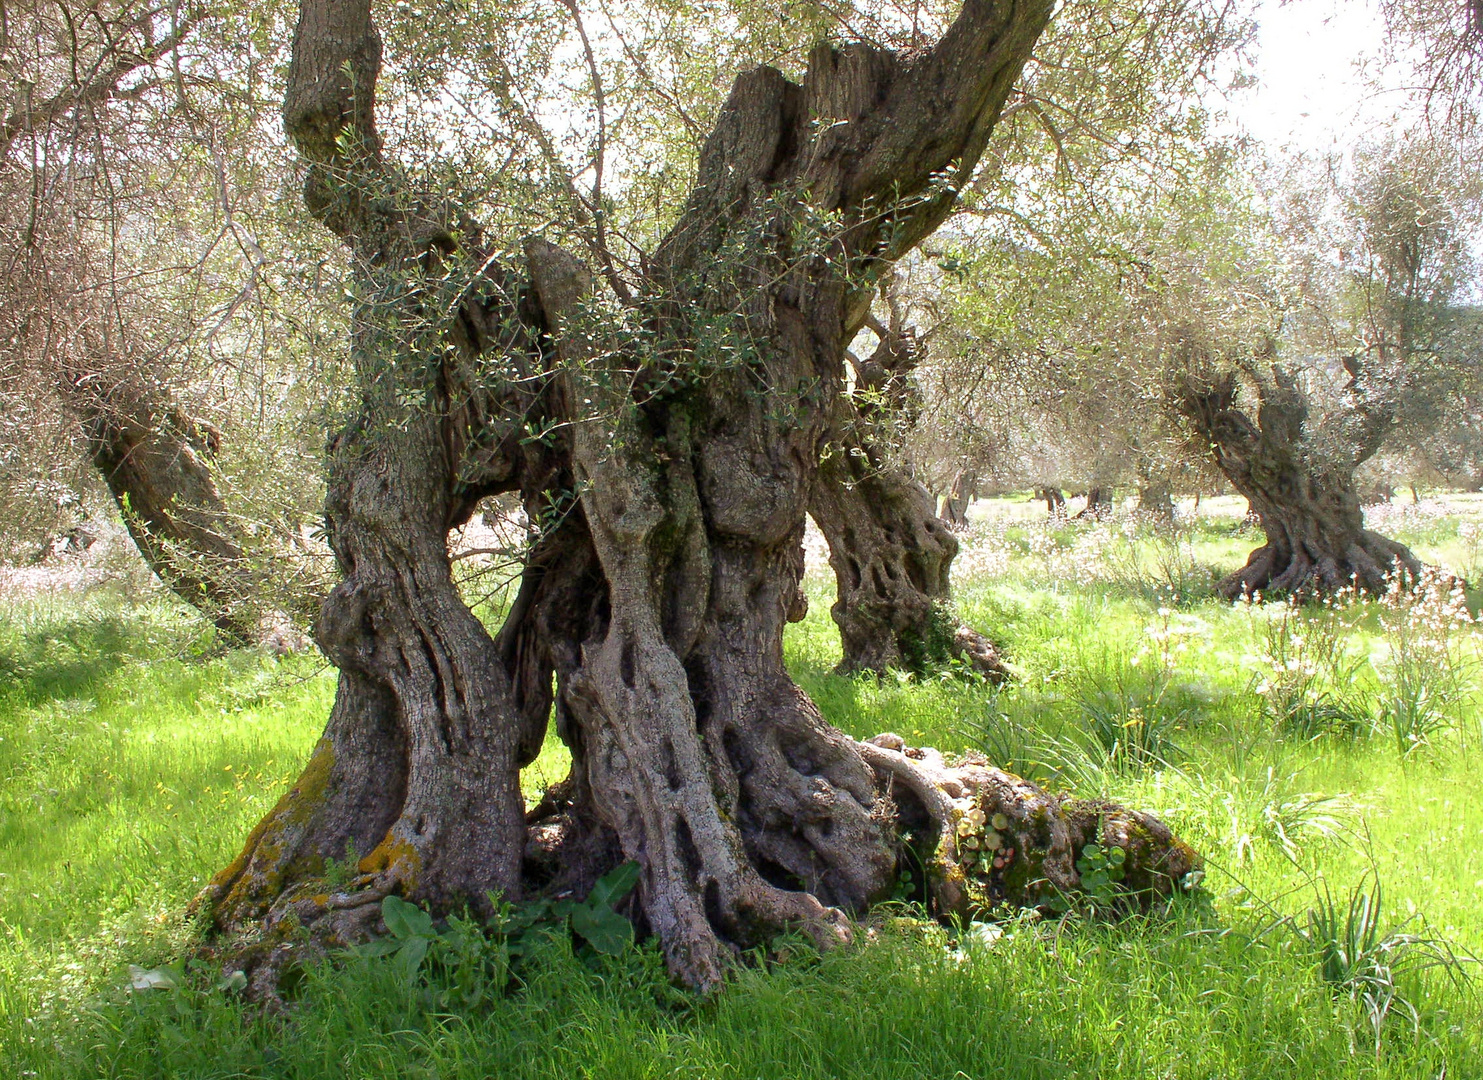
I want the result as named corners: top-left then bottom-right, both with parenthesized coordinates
top-left (0, 495), bottom-right (1483, 1080)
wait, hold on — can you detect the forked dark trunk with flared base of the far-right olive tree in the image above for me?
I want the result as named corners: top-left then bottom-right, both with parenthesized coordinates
top-left (1180, 365), bottom-right (1421, 599)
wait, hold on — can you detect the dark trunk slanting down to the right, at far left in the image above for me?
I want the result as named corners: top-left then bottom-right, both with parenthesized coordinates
top-left (67, 383), bottom-right (264, 644)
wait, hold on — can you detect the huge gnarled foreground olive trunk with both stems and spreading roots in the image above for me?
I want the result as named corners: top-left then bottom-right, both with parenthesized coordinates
top-left (200, 0), bottom-right (1197, 992)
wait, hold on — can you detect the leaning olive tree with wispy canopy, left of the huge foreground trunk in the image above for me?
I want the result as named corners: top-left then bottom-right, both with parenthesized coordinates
top-left (0, 1), bottom-right (340, 642)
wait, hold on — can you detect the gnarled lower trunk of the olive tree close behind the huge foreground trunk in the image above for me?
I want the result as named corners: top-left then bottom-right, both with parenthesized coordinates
top-left (808, 436), bottom-right (1005, 679)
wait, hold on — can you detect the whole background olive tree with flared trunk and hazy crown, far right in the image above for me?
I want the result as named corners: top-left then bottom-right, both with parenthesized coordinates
top-left (1169, 139), bottom-right (1477, 596)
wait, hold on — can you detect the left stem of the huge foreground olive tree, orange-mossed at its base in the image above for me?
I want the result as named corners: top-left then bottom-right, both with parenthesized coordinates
top-left (197, 0), bottom-right (544, 995)
